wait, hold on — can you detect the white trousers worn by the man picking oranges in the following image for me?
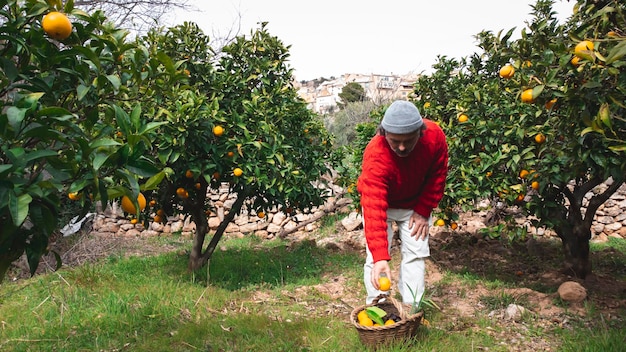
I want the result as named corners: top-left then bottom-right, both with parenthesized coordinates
top-left (363, 209), bottom-right (432, 304)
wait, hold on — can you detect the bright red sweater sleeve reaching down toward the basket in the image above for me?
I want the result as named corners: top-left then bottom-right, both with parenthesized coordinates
top-left (357, 139), bottom-right (391, 262)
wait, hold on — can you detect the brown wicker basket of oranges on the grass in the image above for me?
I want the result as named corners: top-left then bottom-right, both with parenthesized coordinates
top-left (350, 295), bottom-right (424, 348)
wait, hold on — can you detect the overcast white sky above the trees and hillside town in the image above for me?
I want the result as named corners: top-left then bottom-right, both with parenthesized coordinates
top-left (171, 0), bottom-right (575, 80)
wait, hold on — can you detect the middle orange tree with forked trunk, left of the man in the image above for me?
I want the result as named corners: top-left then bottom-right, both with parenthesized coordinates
top-left (138, 23), bottom-right (331, 270)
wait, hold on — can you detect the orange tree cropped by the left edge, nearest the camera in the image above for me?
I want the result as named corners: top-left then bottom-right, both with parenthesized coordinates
top-left (0, 0), bottom-right (171, 280)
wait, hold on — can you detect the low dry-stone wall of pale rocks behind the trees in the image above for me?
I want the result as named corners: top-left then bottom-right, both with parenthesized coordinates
top-left (93, 180), bottom-right (626, 241)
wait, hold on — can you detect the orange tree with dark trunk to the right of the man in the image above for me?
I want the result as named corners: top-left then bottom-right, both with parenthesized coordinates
top-left (415, 0), bottom-right (626, 277)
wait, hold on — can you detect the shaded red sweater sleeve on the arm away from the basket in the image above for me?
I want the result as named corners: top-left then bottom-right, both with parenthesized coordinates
top-left (413, 124), bottom-right (448, 218)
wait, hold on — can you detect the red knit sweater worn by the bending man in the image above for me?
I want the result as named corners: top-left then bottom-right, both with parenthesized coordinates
top-left (357, 119), bottom-right (448, 262)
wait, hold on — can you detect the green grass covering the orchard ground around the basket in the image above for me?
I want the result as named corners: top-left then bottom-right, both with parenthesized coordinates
top-left (0, 223), bottom-right (624, 352)
